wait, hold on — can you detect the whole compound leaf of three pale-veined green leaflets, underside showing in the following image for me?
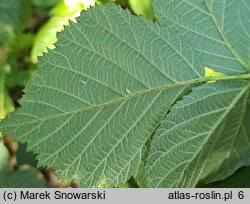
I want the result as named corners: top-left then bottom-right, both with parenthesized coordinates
top-left (0, 0), bottom-right (250, 187)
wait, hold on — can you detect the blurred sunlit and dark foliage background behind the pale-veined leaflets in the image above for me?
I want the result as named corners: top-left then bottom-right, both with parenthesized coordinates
top-left (0, 0), bottom-right (250, 187)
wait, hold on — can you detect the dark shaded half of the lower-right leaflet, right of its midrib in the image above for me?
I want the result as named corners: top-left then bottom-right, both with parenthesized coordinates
top-left (200, 91), bottom-right (250, 183)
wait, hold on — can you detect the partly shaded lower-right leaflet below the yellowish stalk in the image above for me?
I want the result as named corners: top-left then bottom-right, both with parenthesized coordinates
top-left (147, 81), bottom-right (250, 187)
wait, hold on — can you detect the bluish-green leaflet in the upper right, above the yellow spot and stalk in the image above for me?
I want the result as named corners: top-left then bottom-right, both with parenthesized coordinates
top-left (154, 0), bottom-right (250, 74)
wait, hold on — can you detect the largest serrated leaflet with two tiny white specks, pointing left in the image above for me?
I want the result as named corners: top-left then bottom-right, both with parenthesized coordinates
top-left (0, 4), bottom-right (204, 187)
